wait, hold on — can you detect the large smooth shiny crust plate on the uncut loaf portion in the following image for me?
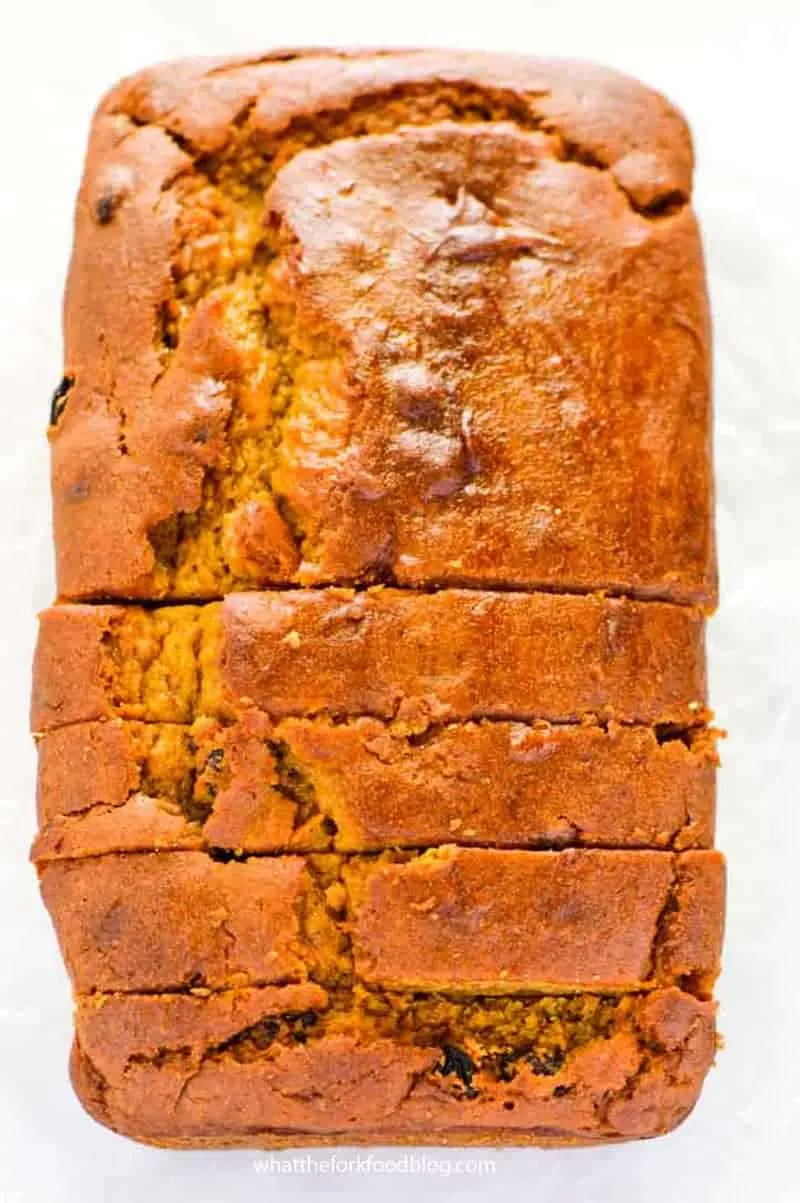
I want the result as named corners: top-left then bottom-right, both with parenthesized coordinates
top-left (261, 125), bottom-right (710, 602)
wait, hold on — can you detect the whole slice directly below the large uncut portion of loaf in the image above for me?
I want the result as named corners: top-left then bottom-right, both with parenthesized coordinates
top-left (31, 588), bottom-right (706, 731)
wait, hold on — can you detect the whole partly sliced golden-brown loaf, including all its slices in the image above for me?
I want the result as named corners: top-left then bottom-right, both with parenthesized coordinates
top-left (31, 51), bottom-right (724, 1148)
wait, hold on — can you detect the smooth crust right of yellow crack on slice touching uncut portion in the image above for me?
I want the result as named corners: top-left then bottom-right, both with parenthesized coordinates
top-left (223, 589), bottom-right (705, 724)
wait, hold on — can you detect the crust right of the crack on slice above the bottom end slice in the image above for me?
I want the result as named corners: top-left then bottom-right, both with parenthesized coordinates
top-left (343, 847), bottom-right (723, 991)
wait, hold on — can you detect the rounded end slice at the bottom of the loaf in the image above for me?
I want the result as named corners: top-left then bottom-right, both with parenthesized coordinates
top-left (71, 985), bottom-right (715, 1148)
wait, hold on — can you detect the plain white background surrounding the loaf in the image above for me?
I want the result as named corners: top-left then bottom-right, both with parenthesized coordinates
top-left (0, 0), bottom-right (800, 1203)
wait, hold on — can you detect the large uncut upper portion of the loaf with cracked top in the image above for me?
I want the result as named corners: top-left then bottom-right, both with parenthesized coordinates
top-left (52, 52), bottom-right (716, 609)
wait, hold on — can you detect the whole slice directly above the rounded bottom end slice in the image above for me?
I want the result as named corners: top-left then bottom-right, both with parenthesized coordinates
top-left (41, 846), bottom-right (723, 994)
